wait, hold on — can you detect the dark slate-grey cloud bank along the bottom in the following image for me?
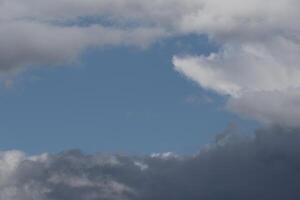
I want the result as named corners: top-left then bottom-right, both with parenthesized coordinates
top-left (0, 127), bottom-right (300, 200)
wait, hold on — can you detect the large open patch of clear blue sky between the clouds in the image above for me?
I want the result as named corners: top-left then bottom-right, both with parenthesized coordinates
top-left (0, 35), bottom-right (255, 154)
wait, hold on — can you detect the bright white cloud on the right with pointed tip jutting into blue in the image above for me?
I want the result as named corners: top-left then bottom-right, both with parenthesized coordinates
top-left (173, 0), bottom-right (300, 126)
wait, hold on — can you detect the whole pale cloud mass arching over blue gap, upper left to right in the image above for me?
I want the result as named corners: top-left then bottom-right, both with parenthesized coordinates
top-left (0, 0), bottom-right (300, 126)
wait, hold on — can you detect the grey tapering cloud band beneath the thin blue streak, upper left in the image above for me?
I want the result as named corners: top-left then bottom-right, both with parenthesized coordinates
top-left (0, 22), bottom-right (164, 72)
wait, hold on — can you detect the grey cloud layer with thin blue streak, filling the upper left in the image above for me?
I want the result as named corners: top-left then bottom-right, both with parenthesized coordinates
top-left (0, 0), bottom-right (203, 73)
